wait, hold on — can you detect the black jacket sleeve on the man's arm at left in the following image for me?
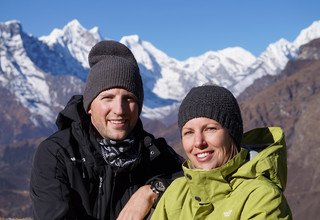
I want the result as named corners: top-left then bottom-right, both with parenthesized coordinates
top-left (30, 140), bottom-right (70, 219)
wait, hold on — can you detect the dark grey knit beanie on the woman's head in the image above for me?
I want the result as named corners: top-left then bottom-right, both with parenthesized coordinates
top-left (178, 85), bottom-right (243, 147)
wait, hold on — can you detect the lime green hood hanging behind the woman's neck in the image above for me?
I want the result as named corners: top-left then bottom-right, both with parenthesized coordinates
top-left (232, 127), bottom-right (287, 191)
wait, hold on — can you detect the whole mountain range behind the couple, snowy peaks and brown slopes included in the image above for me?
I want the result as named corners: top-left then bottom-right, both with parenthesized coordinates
top-left (0, 20), bottom-right (320, 219)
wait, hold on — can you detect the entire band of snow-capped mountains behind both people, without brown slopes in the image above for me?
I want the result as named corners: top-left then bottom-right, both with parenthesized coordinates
top-left (0, 20), bottom-right (320, 128)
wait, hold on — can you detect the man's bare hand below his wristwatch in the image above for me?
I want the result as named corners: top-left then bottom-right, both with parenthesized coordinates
top-left (117, 185), bottom-right (158, 220)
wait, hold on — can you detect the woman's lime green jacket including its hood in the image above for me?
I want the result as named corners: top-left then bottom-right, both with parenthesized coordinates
top-left (151, 127), bottom-right (292, 220)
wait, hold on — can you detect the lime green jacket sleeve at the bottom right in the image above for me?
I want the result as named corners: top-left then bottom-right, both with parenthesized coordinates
top-left (241, 186), bottom-right (292, 219)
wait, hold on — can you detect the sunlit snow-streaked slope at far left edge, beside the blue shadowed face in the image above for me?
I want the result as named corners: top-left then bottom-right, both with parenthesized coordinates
top-left (0, 21), bottom-right (54, 127)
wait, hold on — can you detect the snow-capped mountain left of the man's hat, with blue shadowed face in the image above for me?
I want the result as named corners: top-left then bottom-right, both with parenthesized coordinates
top-left (0, 21), bottom-right (101, 126)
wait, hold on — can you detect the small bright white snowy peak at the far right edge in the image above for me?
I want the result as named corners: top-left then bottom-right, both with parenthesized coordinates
top-left (293, 20), bottom-right (320, 48)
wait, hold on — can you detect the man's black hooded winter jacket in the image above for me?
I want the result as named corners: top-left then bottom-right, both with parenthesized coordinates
top-left (30, 96), bottom-right (182, 219)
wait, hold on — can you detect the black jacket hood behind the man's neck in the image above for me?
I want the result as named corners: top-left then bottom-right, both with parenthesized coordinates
top-left (56, 95), bottom-right (90, 130)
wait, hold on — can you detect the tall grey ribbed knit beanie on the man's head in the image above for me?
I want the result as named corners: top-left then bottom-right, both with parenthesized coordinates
top-left (83, 40), bottom-right (143, 114)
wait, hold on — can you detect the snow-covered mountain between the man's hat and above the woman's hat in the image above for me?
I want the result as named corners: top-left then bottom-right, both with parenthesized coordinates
top-left (120, 35), bottom-right (256, 121)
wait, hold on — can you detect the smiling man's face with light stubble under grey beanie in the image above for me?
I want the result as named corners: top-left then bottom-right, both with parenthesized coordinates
top-left (88, 88), bottom-right (139, 141)
